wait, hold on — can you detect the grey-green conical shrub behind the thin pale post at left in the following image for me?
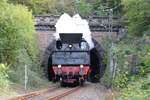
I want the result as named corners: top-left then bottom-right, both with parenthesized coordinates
top-left (9, 49), bottom-right (44, 87)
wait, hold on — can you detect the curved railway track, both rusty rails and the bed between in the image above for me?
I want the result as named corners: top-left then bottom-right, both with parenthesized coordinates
top-left (8, 87), bottom-right (80, 100)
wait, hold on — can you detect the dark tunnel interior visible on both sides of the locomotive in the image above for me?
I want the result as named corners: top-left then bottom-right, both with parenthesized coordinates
top-left (42, 39), bottom-right (106, 82)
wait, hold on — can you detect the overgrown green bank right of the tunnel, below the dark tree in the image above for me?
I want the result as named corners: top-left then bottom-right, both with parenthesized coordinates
top-left (101, 27), bottom-right (150, 100)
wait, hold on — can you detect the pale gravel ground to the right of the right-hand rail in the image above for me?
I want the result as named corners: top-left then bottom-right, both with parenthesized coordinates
top-left (60, 82), bottom-right (108, 100)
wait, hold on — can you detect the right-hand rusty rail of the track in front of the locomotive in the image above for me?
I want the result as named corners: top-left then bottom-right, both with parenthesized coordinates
top-left (48, 86), bottom-right (80, 100)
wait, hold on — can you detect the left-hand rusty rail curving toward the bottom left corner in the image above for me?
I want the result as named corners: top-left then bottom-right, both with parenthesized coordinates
top-left (8, 87), bottom-right (59, 100)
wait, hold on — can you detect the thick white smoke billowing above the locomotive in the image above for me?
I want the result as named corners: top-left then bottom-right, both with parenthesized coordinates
top-left (54, 13), bottom-right (94, 49)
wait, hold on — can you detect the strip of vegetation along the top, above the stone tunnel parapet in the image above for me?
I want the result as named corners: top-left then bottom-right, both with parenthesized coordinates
top-left (9, 0), bottom-right (122, 17)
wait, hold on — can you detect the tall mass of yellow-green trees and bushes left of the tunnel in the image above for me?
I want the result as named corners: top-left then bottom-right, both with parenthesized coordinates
top-left (0, 0), bottom-right (48, 93)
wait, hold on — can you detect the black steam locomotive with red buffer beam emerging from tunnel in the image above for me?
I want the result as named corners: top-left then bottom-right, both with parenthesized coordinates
top-left (52, 33), bottom-right (90, 86)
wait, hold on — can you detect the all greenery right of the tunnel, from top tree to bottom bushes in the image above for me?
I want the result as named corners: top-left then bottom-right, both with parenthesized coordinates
top-left (101, 0), bottom-right (150, 100)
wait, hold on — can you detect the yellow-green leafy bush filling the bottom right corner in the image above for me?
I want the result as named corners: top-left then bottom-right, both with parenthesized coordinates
top-left (116, 74), bottom-right (150, 100)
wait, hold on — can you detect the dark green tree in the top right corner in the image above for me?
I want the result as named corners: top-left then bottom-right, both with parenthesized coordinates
top-left (123, 0), bottom-right (150, 36)
